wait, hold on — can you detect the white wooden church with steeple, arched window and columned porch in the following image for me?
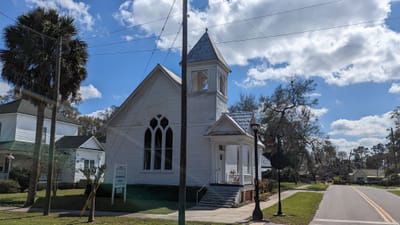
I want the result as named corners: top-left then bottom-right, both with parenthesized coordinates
top-left (105, 32), bottom-right (264, 206)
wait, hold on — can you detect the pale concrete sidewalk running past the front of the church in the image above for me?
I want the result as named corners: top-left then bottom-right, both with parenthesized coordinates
top-left (0, 190), bottom-right (302, 225)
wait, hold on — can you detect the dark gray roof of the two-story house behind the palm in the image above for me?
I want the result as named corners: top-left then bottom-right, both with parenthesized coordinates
top-left (0, 99), bottom-right (78, 124)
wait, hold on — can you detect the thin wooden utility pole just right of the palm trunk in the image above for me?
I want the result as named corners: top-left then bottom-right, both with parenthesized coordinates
top-left (43, 37), bottom-right (62, 216)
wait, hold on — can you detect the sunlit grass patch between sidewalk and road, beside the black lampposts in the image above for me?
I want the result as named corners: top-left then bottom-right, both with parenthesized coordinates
top-left (263, 192), bottom-right (323, 225)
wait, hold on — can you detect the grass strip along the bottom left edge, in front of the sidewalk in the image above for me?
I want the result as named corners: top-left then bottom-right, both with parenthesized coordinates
top-left (0, 211), bottom-right (222, 225)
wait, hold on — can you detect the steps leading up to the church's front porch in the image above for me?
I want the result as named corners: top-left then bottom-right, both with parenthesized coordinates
top-left (198, 185), bottom-right (241, 208)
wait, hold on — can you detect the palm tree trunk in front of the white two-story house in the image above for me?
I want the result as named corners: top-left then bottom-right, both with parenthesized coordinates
top-left (25, 103), bottom-right (45, 207)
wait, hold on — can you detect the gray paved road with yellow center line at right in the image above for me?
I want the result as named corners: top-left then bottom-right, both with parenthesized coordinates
top-left (310, 185), bottom-right (400, 225)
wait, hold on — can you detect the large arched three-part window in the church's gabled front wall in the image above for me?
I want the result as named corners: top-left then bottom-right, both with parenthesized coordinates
top-left (143, 115), bottom-right (173, 170)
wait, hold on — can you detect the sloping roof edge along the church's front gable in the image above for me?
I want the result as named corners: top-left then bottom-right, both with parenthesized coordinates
top-left (106, 64), bottom-right (182, 126)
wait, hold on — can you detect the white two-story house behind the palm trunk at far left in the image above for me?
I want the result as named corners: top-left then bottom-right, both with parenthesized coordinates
top-left (0, 99), bottom-right (104, 185)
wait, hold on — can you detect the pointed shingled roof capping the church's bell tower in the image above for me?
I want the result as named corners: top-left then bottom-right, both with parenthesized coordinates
top-left (187, 31), bottom-right (231, 71)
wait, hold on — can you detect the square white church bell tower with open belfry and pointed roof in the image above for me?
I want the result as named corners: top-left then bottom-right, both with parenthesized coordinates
top-left (187, 30), bottom-right (231, 123)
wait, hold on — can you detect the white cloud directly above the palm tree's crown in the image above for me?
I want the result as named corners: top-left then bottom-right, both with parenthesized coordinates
top-left (25, 0), bottom-right (95, 30)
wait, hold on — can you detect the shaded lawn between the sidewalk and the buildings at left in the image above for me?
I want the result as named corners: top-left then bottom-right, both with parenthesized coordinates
top-left (0, 189), bottom-right (192, 214)
